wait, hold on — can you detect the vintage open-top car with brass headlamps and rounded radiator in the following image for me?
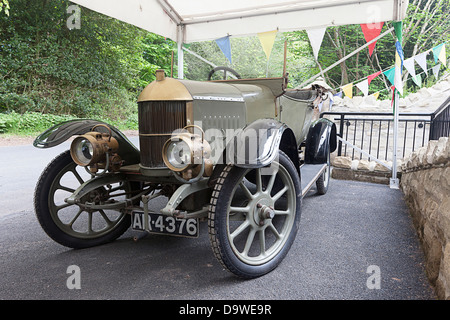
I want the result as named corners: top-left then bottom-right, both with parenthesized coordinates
top-left (34, 68), bottom-right (336, 278)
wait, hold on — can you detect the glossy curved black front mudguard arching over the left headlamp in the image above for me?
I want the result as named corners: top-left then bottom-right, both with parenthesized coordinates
top-left (33, 119), bottom-right (140, 165)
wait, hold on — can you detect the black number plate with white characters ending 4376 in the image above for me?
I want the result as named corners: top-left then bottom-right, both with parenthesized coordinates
top-left (131, 211), bottom-right (198, 238)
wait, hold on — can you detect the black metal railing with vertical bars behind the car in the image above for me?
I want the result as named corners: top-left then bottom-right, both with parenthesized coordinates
top-left (320, 104), bottom-right (450, 161)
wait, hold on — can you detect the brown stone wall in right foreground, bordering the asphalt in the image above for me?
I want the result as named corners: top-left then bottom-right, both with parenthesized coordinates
top-left (401, 138), bottom-right (450, 300)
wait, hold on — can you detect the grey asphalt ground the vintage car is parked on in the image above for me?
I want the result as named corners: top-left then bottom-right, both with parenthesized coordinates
top-left (0, 138), bottom-right (435, 300)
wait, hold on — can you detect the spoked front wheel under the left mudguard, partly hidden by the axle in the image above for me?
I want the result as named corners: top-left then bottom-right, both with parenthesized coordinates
top-left (34, 151), bottom-right (131, 249)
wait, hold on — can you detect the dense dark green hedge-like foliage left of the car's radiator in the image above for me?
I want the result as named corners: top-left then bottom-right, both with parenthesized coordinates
top-left (0, 0), bottom-right (145, 117)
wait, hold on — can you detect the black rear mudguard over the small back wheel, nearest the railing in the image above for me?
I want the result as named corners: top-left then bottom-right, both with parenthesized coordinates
top-left (305, 118), bottom-right (337, 164)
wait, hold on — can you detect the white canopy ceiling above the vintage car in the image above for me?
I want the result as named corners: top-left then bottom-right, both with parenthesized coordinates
top-left (71, 0), bottom-right (408, 43)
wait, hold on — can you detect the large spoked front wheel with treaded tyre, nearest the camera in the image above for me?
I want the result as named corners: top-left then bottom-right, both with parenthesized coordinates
top-left (208, 151), bottom-right (302, 279)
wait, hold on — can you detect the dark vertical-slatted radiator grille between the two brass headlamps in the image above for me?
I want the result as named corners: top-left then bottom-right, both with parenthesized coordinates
top-left (138, 101), bottom-right (187, 168)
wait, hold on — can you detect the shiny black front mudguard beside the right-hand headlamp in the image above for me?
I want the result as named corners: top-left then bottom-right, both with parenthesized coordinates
top-left (226, 119), bottom-right (299, 175)
